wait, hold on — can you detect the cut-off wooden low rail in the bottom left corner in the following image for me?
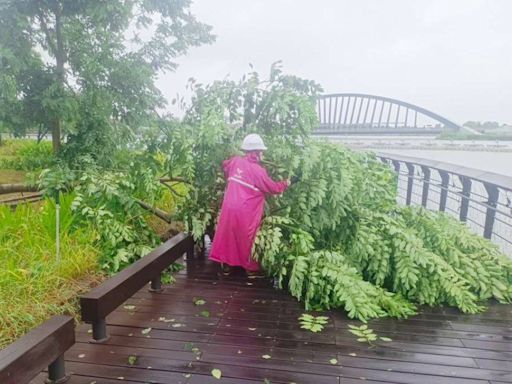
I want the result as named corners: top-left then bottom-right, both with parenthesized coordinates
top-left (0, 316), bottom-right (75, 384)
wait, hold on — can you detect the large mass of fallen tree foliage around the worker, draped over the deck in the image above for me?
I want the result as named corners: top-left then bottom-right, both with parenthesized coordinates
top-left (158, 64), bottom-right (512, 321)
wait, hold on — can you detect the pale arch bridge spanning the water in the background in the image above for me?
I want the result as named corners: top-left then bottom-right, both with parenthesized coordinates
top-left (315, 93), bottom-right (462, 135)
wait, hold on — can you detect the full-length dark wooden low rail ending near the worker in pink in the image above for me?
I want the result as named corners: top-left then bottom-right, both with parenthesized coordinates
top-left (80, 233), bottom-right (194, 342)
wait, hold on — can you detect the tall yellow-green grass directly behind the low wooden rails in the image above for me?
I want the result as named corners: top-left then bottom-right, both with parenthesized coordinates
top-left (0, 196), bottom-right (98, 348)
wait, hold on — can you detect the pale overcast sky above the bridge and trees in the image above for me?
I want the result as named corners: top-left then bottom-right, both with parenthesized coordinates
top-left (158, 0), bottom-right (512, 123)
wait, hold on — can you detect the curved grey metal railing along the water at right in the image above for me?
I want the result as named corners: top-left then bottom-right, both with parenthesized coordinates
top-left (376, 153), bottom-right (512, 256)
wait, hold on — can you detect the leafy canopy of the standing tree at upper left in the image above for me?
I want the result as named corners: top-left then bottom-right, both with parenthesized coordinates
top-left (0, 0), bottom-right (214, 159)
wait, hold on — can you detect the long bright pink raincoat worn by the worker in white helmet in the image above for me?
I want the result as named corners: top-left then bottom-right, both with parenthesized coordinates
top-left (209, 152), bottom-right (288, 271)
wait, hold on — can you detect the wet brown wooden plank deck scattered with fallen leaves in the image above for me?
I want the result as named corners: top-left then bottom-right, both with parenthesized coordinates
top-left (33, 255), bottom-right (512, 384)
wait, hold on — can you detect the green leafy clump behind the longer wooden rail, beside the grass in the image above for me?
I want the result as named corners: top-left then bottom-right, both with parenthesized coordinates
top-left (40, 157), bottom-right (161, 273)
